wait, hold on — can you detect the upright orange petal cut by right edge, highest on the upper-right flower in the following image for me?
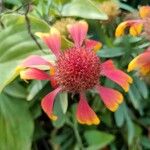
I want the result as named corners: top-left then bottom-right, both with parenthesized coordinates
top-left (139, 6), bottom-right (150, 18)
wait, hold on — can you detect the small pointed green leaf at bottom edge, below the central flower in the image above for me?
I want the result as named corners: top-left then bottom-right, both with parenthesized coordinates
top-left (84, 130), bottom-right (115, 150)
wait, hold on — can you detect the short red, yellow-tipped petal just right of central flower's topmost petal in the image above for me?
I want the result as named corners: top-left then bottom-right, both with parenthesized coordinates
top-left (85, 39), bottom-right (102, 52)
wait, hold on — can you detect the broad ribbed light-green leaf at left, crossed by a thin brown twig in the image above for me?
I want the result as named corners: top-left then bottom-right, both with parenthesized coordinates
top-left (0, 14), bottom-right (50, 91)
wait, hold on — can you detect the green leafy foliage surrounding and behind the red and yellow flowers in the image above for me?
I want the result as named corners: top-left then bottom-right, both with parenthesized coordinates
top-left (0, 0), bottom-right (150, 150)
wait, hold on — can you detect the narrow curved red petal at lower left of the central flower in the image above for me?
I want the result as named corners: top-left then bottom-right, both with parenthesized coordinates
top-left (41, 87), bottom-right (61, 121)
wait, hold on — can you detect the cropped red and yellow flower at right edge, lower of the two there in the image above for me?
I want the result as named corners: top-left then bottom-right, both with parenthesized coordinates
top-left (128, 48), bottom-right (150, 76)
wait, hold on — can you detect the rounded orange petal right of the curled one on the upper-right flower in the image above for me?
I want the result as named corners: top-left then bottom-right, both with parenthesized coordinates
top-left (129, 23), bottom-right (143, 36)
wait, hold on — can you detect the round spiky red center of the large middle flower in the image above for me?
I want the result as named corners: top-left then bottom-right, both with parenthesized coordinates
top-left (56, 48), bottom-right (100, 92)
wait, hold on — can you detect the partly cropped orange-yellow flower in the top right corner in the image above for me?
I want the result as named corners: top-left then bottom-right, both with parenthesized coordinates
top-left (115, 6), bottom-right (150, 37)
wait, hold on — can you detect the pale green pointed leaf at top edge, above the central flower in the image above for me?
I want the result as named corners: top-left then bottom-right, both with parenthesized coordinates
top-left (61, 0), bottom-right (108, 20)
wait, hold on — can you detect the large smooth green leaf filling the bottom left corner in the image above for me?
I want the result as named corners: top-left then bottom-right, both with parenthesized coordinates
top-left (0, 93), bottom-right (34, 150)
